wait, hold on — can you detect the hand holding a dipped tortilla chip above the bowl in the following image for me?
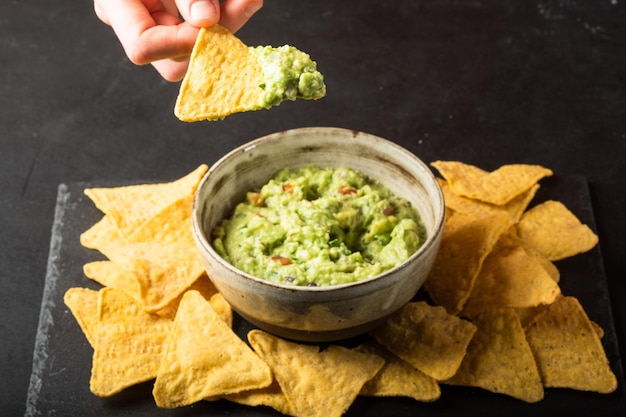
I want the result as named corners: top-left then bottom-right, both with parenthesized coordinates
top-left (94, 0), bottom-right (263, 81)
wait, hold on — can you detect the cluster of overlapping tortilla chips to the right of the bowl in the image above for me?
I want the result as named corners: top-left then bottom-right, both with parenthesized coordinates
top-left (425, 161), bottom-right (617, 402)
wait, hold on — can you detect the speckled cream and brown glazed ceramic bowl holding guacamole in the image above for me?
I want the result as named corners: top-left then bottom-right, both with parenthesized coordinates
top-left (193, 127), bottom-right (445, 342)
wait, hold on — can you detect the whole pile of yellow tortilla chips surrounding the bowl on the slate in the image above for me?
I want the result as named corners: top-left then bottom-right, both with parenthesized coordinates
top-left (65, 162), bottom-right (616, 417)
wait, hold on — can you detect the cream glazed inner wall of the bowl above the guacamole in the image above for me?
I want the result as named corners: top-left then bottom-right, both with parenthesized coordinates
top-left (194, 128), bottom-right (444, 276)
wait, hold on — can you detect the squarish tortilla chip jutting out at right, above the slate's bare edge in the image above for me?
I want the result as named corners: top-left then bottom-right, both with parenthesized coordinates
top-left (517, 200), bottom-right (598, 261)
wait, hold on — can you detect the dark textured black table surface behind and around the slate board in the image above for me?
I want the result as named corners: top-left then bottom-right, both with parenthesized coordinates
top-left (0, 0), bottom-right (626, 416)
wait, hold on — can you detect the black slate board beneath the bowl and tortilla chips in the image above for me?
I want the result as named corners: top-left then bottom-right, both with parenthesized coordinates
top-left (25, 176), bottom-right (626, 417)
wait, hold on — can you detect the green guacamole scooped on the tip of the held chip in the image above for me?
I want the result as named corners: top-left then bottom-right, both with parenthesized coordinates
top-left (249, 45), bottom-right (326, 107)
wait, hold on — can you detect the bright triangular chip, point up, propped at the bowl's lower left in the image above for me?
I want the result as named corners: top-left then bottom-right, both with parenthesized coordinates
top-left (153, 291), bottom-right (272, 408)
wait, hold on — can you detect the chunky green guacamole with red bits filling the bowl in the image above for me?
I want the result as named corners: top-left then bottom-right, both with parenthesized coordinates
top-left (213, 166), bottom-right (426, 286)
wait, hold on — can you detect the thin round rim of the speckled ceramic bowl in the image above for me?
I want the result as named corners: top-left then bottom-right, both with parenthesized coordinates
top-left (191, 126), bottom-right (446, 293)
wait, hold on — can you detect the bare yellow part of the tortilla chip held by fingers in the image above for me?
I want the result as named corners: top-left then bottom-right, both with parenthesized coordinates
top-left (174, 25), bottom-right (264, 122)
